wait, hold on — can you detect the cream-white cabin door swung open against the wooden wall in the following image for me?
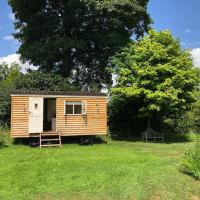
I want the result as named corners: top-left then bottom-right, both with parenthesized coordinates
top-left (29, 97), bottom-right (43, 133)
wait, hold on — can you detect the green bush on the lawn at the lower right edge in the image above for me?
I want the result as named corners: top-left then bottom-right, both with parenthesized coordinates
top-left (182, 145), bottom-right (200, 180)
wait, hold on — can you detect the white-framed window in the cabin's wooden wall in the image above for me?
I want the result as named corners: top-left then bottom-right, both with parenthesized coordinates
top-left (65, 101), bottom-right (86, 115)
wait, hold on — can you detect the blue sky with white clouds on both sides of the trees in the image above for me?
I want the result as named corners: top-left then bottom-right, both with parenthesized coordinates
top-left (0, 0), bottom-right (200, 68)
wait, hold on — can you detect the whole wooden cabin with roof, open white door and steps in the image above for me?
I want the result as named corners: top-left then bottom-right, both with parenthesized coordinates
top-left (11, 90), bottom-right (107, 146)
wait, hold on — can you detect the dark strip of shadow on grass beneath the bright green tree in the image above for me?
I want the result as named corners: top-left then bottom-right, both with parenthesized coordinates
top-left (111, 134), bottom-right (192, 144)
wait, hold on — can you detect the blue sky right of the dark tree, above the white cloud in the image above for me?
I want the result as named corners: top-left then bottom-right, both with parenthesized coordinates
top-left (149, 0), bottom-right (200, 49)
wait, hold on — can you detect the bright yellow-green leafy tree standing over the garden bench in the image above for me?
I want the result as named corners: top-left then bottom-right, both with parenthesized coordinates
top-left (112, 30), bottom-right (200, 132)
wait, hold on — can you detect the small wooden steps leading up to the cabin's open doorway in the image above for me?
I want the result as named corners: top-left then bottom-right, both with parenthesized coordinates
top-left (40, 132), bottom-right (61, 148)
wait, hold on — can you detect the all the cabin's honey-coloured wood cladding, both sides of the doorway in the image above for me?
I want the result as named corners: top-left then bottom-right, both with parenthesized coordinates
top-left (11, 94), bottom-right (107, 137)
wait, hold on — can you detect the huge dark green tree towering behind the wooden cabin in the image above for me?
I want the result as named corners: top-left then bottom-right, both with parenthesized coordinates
top-left (9, 0), bottom-right (151, 87)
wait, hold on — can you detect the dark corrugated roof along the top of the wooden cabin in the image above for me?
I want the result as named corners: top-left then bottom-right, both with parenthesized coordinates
top-left (11, 89), bottom-right (106, 96)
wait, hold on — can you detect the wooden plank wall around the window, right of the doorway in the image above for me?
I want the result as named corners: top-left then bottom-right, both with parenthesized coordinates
top-left (57, 97), bottom-right (107, 136)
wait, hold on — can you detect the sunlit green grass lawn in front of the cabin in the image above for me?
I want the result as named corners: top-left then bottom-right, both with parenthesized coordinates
top-left (0, 133), bottom-right (200, 200)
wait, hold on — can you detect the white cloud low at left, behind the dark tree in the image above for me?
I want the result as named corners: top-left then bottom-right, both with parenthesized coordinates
top-left (0, 54), bottom-right (37, 73)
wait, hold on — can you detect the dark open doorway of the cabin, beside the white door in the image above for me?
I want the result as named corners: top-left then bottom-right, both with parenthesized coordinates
top-left (43, 98), bottom-right (56, 131)
